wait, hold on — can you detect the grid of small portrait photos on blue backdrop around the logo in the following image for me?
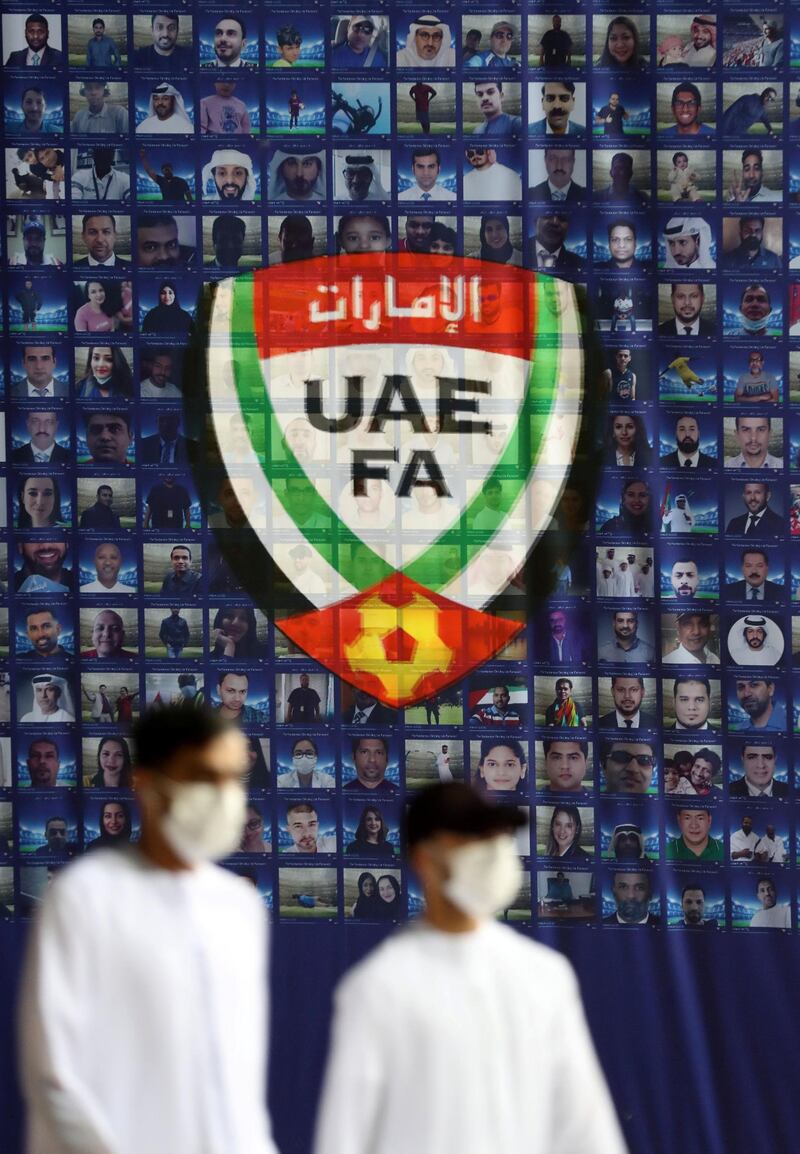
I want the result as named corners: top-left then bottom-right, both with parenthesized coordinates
top-left (0, 0), bottom-right (800, 932)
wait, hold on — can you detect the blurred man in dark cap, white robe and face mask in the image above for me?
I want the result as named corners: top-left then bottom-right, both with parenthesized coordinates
top-left (315, 781), bottom-right (626, 1154)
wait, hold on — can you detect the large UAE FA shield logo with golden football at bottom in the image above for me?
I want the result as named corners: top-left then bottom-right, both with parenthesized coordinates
top-left (207, 253), bottom-right (583, 706)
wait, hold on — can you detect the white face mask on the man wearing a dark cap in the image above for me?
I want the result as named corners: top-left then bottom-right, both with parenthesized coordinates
top-left (442, 833), bottom-right (522, 917)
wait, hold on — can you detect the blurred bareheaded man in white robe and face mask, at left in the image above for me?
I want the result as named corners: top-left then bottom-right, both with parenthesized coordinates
top-left (20, 706), bottom-right (276, 1154)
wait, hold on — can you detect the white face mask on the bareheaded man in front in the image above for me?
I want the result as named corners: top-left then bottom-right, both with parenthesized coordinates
top-left (151, 778), bottom-right (247, 866)
